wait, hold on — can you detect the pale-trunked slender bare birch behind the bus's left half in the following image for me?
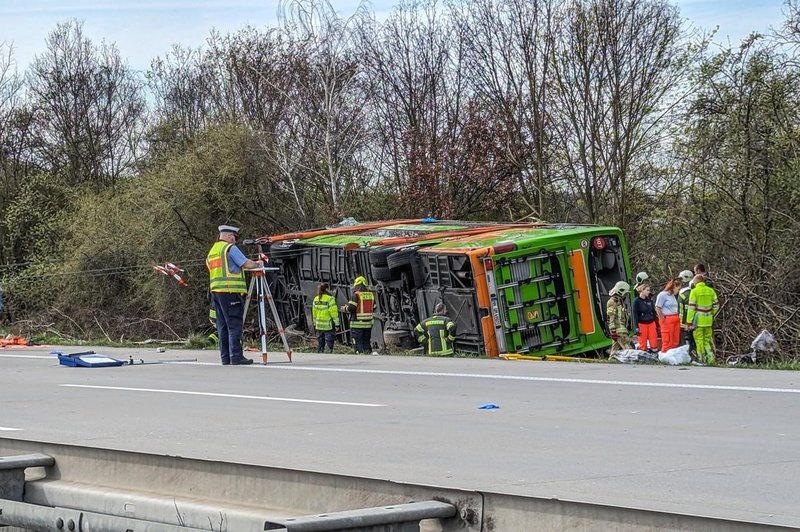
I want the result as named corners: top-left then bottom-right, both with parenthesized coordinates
top-left (276, 0), bottom-right (365, 217)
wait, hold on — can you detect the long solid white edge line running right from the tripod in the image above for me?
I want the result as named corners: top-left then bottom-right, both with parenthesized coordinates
top-left (244, 365), bottom-right (800, 393)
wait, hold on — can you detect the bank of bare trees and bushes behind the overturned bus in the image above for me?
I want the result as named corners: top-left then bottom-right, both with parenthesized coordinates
top-left (0, 0), bottom-right (800, 362)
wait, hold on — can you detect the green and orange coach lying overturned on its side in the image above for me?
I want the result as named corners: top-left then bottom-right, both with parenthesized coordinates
top-left (256, 219), bottom-right (630, 356)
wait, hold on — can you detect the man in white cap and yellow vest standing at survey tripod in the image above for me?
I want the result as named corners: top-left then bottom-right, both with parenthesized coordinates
top-left (206, 225), bottom-right (264, 366)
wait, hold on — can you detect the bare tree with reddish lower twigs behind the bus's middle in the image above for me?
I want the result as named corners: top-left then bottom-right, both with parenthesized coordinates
top-left (361, 2), bottom-right (466, 214)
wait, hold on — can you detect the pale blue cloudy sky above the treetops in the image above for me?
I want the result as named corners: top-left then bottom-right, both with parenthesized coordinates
top-left (0, 0), bottom-right (783, 69)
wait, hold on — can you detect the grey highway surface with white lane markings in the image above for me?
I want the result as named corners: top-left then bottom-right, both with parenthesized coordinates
top-left (0, 347), bottom-right (800, 527)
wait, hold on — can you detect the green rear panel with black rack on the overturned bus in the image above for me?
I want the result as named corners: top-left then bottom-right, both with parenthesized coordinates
top-left (493, 249), bottom-right (580, 353)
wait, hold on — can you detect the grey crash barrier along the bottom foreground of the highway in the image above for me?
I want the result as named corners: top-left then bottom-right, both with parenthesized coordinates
top-left (0, 438), bottom-right (791, 532)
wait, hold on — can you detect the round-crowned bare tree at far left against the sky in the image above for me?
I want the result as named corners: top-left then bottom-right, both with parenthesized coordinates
top-left (27, 21), bottom-right (145, 185)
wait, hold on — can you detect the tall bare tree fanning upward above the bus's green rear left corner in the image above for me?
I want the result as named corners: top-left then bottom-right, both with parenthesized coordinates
top-left (452, 0), bottom-right (561, 218)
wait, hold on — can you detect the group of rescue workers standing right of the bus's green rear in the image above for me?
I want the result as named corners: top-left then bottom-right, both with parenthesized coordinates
top-left (606, 264), bottom-right (719, 364)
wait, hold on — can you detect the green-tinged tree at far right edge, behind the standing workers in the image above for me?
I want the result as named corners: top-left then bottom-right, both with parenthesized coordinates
top-left (682, 40), bottom-right (800, 353)
